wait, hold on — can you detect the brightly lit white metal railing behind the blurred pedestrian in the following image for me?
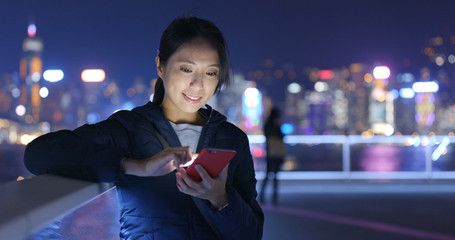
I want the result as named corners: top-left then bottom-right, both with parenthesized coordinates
top-left (248, 135), bottom-right (455, 180)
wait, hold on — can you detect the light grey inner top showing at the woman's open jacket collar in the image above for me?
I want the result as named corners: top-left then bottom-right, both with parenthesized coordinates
top-left (170, 122), bottom-right (202, 152)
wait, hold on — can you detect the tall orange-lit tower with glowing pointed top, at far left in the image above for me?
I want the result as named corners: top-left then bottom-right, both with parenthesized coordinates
top-left (19, 24), bottom-right (43, 124)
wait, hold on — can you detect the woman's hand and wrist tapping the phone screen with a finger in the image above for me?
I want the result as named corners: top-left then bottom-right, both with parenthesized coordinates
top-left (122, 147), bottom-right (191, 177)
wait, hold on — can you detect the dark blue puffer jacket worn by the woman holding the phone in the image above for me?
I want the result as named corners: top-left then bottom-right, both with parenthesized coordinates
top-left (24, 102), bottom-right (264, 240)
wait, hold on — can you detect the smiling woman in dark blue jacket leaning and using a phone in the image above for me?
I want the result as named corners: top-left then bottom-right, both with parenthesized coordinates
top-left (24, 17), bottom-right (264, 239)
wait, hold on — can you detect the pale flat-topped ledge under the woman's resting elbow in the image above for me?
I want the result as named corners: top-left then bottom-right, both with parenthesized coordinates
top-left (0, 175), bottom-right (113, 239)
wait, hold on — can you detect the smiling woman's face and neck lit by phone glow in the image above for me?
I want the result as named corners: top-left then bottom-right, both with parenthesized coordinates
top-left (156, 38), bottom-right (220, 122)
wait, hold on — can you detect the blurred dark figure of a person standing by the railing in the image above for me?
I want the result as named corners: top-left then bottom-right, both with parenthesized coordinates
top-left (259, 108), bottom-right (286, 204)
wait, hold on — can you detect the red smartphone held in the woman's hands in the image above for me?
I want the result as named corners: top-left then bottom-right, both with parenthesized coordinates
top-left (186, 148), bottom-right (237, 182)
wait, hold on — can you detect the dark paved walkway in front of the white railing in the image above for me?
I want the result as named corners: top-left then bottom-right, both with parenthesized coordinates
top-left (263, 181), bottom-right (455, 240)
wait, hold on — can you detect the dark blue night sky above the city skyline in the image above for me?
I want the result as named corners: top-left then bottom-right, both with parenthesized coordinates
top-left (0, 0), bottom-right (455, 101)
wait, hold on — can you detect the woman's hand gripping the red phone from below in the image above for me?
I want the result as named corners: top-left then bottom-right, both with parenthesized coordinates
top-left (176, 164), bottom-right (229, 209)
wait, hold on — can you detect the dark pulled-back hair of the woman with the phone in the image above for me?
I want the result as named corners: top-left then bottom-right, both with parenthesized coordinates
top-left (153, 17), bottom-right (229, 104)
